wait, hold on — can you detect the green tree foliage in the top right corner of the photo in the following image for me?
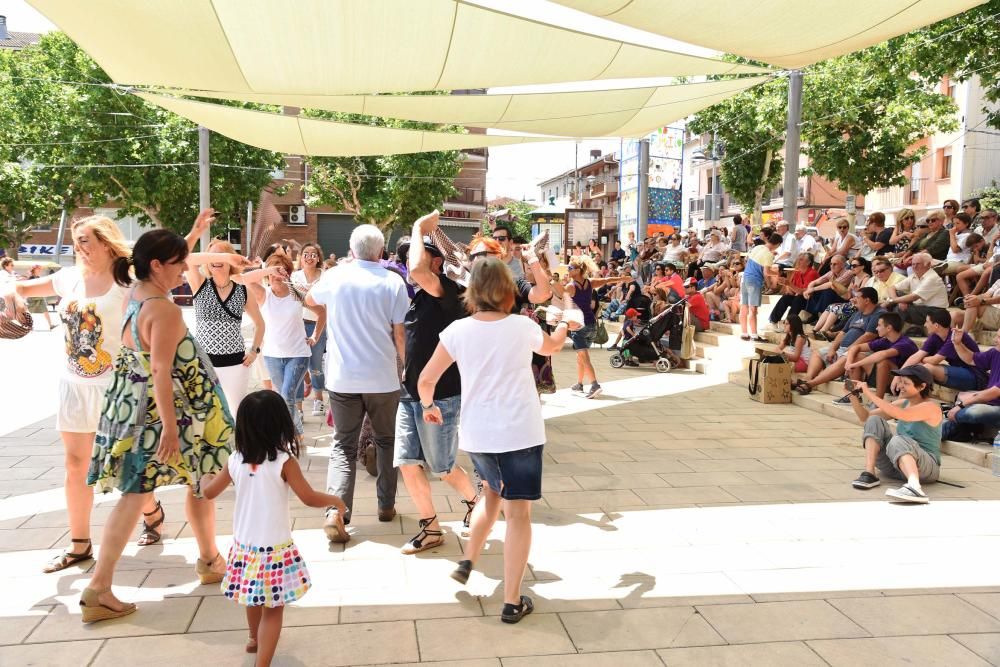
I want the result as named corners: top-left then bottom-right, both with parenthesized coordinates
top-left (889, 0), bottom-right (1000, 128)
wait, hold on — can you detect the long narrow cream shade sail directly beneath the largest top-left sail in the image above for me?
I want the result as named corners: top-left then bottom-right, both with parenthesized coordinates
top-left (154, 76), bottom-right (769, 137)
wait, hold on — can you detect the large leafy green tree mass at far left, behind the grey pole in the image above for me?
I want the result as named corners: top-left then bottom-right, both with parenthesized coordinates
top-left (0, 32), bottom-right (284, 237)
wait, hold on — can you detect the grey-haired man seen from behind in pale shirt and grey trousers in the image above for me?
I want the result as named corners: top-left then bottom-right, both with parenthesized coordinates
top-left (306, 225), bottom-right (410, 542)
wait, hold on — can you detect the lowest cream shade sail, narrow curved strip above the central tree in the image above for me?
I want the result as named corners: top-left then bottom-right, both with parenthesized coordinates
top-left (136, 93), bottom-right (561, 157)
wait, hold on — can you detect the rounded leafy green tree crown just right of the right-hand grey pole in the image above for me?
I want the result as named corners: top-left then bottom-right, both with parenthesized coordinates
top-left (802, 43), bottom-right (958, 219)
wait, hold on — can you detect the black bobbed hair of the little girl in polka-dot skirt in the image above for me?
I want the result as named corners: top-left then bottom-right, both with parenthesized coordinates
top-left (235, 389), bottom-right (299, 464)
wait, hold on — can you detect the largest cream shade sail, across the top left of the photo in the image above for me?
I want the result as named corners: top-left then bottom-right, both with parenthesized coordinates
top-left (28, 0), bottom-right (766, 95)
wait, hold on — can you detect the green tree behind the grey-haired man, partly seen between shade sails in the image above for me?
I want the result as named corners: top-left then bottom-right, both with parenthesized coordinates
top-left (304, 106), bottom-right (463, 237)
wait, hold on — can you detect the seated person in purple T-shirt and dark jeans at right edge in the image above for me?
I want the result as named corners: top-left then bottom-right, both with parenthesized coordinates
top-left (943, 330), bottom-right (1000, 440)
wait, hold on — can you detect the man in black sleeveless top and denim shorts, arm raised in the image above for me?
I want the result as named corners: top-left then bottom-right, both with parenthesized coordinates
top-left (393, 211), bottom-right (476, 554)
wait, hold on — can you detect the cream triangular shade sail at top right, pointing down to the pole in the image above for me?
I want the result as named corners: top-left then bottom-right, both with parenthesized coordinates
top-left (552, 0), bottom-right (985, 69)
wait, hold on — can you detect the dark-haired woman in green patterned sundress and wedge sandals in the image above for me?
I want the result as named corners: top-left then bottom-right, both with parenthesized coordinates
top-left (80, 229), bottom-right (238, 623)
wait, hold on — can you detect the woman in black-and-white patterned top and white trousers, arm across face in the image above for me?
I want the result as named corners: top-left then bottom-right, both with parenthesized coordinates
top-left (187, 232), bottom-right (271, 415)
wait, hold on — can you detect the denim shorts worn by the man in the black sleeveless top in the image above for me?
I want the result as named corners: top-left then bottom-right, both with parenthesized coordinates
top-left (392, 396), bottom-right (462, 476)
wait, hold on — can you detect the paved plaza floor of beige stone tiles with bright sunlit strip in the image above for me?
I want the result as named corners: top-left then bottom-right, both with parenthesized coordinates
top-left (0, 350), bottom-right (1000, 667)
